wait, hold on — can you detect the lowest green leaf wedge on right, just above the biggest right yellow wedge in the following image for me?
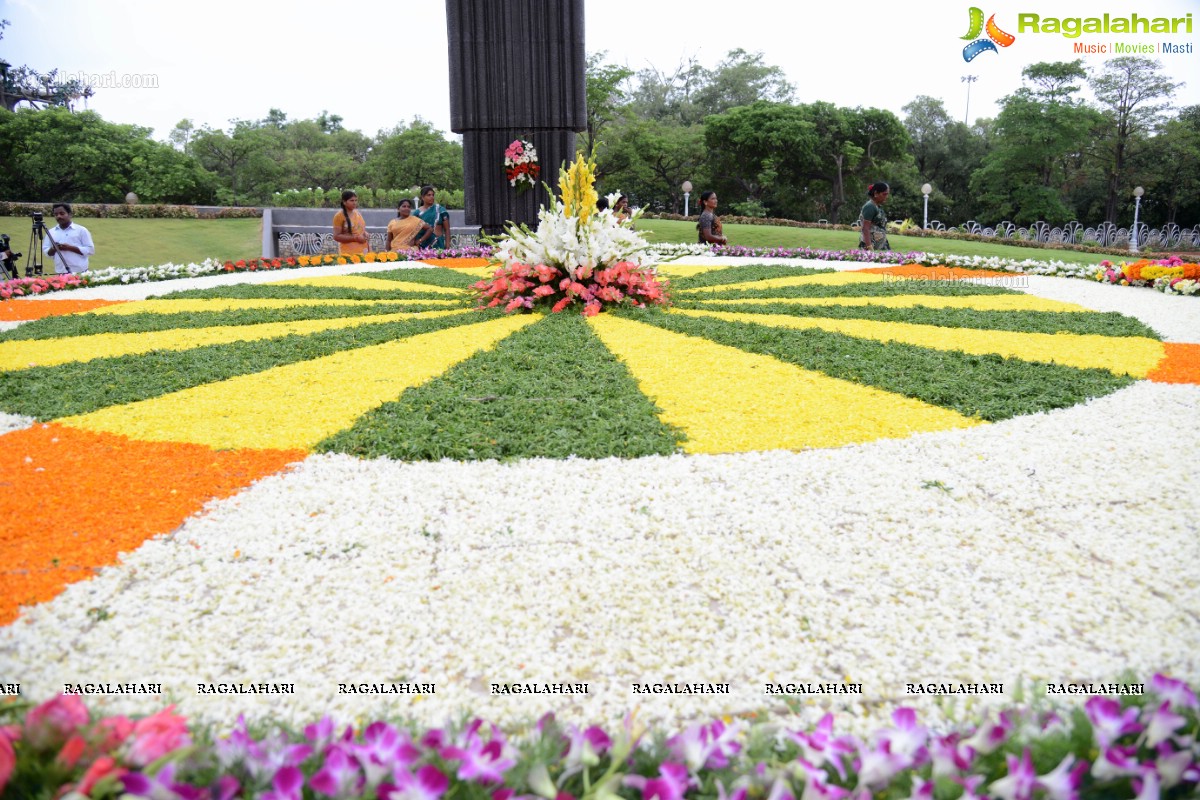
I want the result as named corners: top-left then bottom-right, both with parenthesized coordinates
top-left (622, 311), bottom-right (1134, 422)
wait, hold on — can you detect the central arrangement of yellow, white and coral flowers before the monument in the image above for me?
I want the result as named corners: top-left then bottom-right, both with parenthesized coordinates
top-left (472, 149), bottom-right (667, 317)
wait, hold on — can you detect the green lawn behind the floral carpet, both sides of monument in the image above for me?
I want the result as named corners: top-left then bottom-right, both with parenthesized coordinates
top-left (0, 217), bottom-right (1111, 269)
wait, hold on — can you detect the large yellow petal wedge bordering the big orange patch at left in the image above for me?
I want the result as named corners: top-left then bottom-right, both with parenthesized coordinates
top-left (60, 314), bottom-right (539, 450)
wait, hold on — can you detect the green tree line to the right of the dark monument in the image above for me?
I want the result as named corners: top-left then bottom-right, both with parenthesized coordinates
top-left (583, 50), bottom-right (1200, 225)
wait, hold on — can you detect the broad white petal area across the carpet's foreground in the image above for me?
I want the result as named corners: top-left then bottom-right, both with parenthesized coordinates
top-left (0, 381), bottom-right (1200, 730)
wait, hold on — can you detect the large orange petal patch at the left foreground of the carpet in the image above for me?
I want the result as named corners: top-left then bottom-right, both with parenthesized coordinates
top-left (0, 423), bottom-right (308, 625)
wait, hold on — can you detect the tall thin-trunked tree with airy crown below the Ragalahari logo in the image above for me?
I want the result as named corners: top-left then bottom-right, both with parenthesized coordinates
top-left (1091, 55), bottom-right (1182, 222)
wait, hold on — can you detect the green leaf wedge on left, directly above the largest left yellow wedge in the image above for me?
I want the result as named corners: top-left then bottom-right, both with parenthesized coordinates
top-left (0, 312), bottom-right (489, 421)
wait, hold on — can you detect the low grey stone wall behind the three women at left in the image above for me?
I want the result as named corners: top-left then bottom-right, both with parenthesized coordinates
top-left (263, 209), bottom-right (480, 258)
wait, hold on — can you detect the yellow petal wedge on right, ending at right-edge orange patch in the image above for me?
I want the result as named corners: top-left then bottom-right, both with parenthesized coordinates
top-left (670, 309), bottom-right (1165, 378)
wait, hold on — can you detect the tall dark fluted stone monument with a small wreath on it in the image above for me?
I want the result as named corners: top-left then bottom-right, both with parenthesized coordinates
top-left (446, 0), bottom-right (587, 235)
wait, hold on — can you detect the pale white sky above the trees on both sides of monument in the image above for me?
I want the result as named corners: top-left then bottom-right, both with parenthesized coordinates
top-left (0, 0), bottom-right (1200, 140)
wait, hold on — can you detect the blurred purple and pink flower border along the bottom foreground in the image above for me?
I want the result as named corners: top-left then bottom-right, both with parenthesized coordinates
top-left (0, 675), bottom-right (1200, 800)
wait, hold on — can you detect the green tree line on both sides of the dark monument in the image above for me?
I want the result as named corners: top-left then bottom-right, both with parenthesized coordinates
top-left (0, 26), bottom-right (1200, 225)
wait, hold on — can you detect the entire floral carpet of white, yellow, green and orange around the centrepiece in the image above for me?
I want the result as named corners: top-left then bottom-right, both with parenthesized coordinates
top-left (0, 258), bottom-right (1200, 729)
